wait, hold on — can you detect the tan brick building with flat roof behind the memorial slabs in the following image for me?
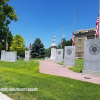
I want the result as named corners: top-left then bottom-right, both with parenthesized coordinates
top-left (75, 28), bottom-right (96, 59)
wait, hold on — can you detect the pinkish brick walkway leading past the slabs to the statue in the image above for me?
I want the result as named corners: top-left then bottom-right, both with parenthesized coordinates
top-left (39, 60), bottom-right (100, 84)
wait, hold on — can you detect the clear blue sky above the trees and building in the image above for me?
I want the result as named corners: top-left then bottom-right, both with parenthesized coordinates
top-left (8, 0), bottom-right (99, 48)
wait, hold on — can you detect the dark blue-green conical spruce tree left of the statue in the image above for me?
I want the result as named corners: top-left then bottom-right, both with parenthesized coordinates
top-left (31, 38), bottom-right (45, 58)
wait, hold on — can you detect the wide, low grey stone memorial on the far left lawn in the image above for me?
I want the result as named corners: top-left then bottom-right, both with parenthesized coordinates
top-left (4, 51), bottom-right (17, 62)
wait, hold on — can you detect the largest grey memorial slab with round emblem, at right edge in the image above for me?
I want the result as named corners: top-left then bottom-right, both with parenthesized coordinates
top-left (82, 39), bottom-right (100, 76)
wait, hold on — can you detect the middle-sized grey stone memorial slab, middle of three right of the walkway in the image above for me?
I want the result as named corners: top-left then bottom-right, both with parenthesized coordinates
top-left (64, 46), bottom-right (76, 66)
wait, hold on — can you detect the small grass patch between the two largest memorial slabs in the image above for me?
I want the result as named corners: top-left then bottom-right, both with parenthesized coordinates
top-left (68, 59), bottom-right (83, 73)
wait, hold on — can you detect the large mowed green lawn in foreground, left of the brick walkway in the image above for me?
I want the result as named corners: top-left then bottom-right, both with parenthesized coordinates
top-left (0, 61), bottom-right (100, 100)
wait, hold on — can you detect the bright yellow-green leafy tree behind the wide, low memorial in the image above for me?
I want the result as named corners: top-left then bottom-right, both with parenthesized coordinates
top-left (10, 34), bottom-right (25, 56)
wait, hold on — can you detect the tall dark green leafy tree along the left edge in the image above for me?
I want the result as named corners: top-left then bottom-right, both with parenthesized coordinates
top-left (0, 0), bottom-right (18, 51)
